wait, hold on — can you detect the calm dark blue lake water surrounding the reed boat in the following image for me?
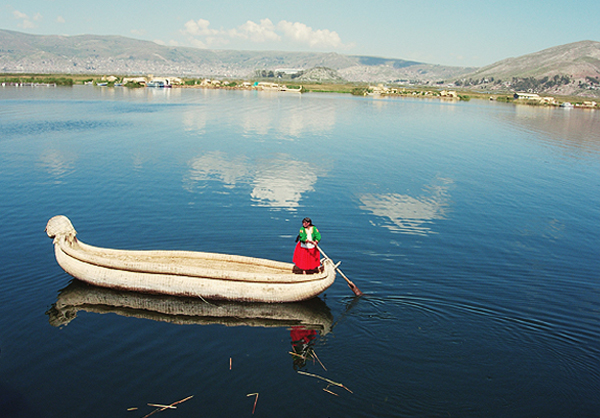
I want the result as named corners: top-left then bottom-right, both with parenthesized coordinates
top-left (0, 87), bottom-right (600, 418)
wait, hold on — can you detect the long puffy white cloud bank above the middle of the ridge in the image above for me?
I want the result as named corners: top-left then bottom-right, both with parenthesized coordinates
top-left (181, 19), bottom-right (347, 49)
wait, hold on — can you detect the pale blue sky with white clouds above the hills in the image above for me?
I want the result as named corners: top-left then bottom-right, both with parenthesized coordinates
top-left (0, 0), bottom-right (600, 67)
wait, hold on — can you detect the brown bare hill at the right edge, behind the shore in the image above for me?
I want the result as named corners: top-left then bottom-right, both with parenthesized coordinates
top-left (456, 41), bottom-right (600, 97)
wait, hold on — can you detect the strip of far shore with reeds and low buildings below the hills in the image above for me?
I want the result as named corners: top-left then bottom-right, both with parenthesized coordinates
top-left (0, 74), bottom-right (600, 109)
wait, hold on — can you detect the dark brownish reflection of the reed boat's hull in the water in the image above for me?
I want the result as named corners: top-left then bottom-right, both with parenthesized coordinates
top-left (46, 279), bottom-right (333, 335)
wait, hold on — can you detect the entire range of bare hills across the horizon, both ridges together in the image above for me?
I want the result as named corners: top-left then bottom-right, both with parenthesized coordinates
top-left (0, 30), bottom-right (600, 97)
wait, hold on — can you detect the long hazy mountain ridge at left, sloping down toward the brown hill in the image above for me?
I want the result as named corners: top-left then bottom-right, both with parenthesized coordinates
top-left (0, 30), bottom-right (475, 82)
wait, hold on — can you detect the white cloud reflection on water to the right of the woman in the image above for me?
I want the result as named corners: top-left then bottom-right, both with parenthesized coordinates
top-left (360, 178), bottom-right (453, 235)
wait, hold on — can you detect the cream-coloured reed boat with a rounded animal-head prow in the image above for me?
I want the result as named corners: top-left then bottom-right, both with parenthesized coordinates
top-left (46, 215), bottom-right (337, 303)
